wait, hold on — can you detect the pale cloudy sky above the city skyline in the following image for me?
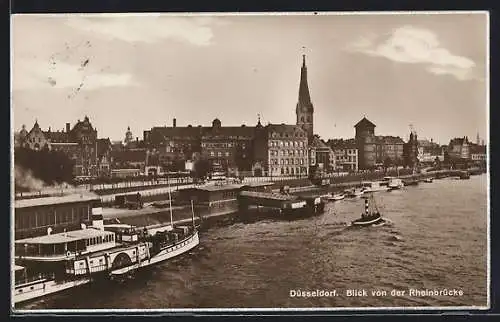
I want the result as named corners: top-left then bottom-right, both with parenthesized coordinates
top-left (12, 13), bottom-right (488, 144)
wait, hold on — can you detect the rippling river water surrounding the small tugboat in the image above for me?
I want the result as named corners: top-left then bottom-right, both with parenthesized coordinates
top-left (23, 174), bottom-right (488, 309)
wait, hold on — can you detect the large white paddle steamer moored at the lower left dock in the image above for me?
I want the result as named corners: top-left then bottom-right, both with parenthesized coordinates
top-left (12, 197), bottom-right (199, 304)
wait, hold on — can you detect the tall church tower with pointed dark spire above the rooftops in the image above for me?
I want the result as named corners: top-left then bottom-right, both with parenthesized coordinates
top-left (295, 55), bottom-right (314, 139)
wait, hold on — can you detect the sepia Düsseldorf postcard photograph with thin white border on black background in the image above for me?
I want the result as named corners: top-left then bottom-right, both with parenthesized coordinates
top-left (10, 11), bottom-right (491, 313)
